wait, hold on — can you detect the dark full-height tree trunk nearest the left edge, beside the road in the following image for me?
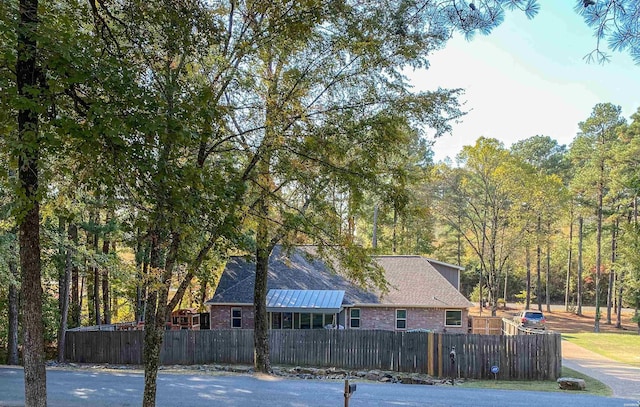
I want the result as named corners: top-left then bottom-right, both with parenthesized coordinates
top-left (16, 0), bottom-right (47, 407)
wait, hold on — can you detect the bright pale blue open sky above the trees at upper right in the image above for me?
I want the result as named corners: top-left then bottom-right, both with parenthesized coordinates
top-left (407, 0), bottom-right (640, 161)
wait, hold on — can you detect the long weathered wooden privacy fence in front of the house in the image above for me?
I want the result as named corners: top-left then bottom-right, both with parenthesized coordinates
top-left (65, 329), bottom-right (562, 380)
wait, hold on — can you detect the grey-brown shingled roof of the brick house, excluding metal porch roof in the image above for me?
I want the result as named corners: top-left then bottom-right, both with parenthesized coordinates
top-left (207, 247), bottom-right (471, 308)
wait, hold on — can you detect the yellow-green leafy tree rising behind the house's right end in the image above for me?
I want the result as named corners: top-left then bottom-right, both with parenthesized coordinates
top-left (436, 138), bottom-right (530, 315)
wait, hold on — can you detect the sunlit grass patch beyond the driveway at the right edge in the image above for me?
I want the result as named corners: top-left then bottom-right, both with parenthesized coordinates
top-left (562, 332), bottom-right (640, 367)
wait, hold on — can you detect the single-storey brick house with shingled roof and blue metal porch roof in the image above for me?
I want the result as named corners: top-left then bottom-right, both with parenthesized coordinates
top-left (206, 247), bottom-right (471, 332)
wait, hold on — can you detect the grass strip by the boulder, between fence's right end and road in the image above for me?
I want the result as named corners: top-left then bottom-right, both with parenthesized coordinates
top-left (460, 367), bottom-right (613, 397)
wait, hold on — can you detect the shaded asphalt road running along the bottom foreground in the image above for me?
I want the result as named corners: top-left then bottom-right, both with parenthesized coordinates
top-left (0, 367), bottom-right (638, 407)
